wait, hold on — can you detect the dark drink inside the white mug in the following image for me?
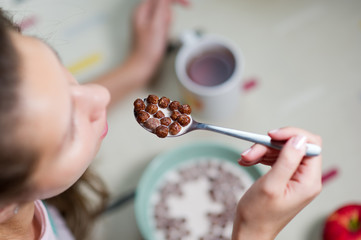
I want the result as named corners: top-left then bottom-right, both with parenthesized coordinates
top-left (187, 47), bottom-right (235, 87)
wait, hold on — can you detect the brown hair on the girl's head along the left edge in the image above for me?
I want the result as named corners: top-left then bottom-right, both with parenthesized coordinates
top-left (0, 7), bottom-right (36, 208)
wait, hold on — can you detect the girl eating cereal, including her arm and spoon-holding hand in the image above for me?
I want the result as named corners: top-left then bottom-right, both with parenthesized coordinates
top-left (0, 0), bottom-right (321, 240)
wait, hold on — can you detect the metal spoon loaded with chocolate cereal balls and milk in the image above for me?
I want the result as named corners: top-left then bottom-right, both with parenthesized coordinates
top-left (134, 95), bottom-right (321, 156)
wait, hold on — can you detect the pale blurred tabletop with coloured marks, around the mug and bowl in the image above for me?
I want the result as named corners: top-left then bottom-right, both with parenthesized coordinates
top-left (0, 0), bottom-right (361, 240)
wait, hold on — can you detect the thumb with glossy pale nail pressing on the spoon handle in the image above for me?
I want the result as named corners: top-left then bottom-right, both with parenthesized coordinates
top-left (267, 135), bottom-right (306, 189)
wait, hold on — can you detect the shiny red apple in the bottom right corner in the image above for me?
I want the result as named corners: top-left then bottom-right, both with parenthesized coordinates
top-left (323, 204), bottom-right (361, 240)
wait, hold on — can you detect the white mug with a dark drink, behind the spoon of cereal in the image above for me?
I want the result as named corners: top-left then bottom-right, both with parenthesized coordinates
top-left (175, 31), bottom-right (244, 120)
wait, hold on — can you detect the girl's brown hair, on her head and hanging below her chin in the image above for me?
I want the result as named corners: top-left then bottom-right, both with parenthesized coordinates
top-left (0, 8), bottom-right (108, 240)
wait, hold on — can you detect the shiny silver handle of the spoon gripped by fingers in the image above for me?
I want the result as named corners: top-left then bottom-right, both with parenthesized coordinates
top-left (196, 123), bottom-right (321, 157)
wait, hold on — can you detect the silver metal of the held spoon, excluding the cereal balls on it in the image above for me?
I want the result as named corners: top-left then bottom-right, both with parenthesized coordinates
top-left (134, 111), bottom-right (321, 157)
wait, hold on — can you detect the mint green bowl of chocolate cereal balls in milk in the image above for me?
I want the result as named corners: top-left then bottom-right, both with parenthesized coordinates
top-left (135, 142), bottom-right (261, 240)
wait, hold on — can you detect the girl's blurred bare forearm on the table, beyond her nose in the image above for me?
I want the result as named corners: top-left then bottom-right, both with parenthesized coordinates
top-left (93, 53), bottom-right (156, 107)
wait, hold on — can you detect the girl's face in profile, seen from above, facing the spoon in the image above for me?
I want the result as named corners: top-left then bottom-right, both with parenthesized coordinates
top-left (12, 33), bottom-right (110, 199)
